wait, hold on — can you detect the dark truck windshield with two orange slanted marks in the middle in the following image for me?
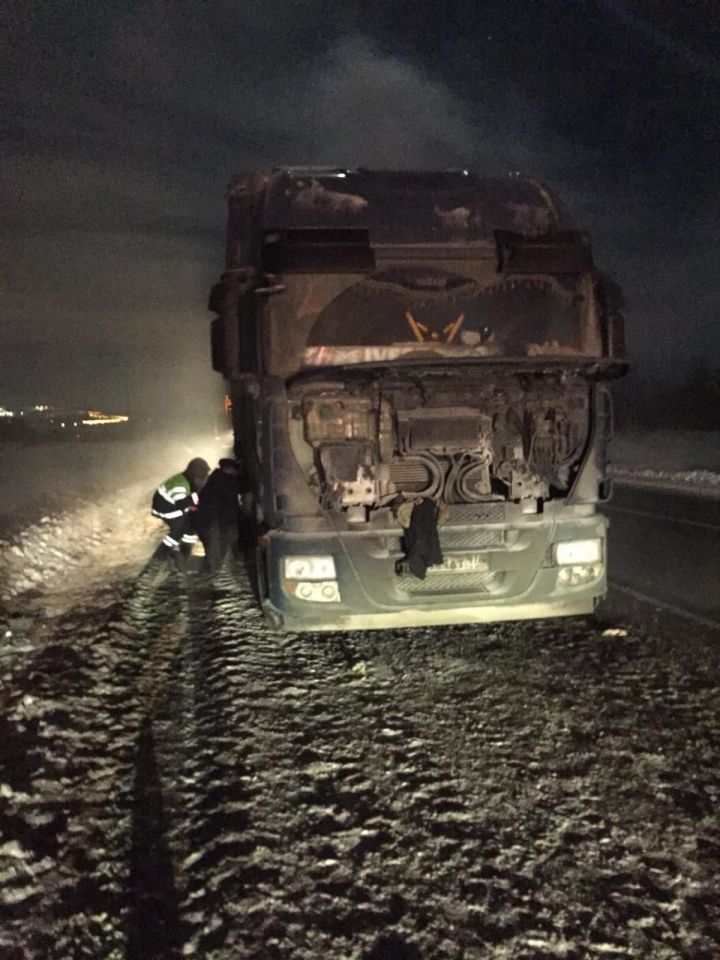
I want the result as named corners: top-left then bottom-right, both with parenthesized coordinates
top-left (304, 266), bottom-right (583, 365)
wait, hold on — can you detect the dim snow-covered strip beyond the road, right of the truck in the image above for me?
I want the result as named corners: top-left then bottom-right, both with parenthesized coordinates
top-left (611, 430), bottom-right (720, 497)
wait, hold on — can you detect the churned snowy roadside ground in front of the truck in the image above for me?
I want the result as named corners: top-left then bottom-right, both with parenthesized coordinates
top-left (0, 452), bottom-right (720, 960)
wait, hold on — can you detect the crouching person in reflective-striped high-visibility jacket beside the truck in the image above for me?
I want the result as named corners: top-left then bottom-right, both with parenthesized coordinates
top-left (150, 457), bottom-right (210, 570)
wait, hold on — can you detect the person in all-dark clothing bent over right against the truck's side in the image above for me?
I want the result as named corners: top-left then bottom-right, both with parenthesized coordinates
top-left (192, 457), bottom-right (240, 573)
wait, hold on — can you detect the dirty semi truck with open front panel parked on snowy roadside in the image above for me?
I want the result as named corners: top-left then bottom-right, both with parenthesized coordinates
top-left (210, 168), bottom-right (625, 630)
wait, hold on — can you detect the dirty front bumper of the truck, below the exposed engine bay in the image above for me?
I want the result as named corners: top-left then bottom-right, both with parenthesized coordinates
top-left (263, 514), bottom-right (607, 631)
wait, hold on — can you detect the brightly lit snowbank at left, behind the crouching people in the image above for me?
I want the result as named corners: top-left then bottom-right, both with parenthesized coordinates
top-left (0, 436), bottom-right (230, 613)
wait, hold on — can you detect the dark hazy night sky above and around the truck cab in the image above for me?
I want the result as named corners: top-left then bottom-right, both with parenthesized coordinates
top-left (0, 0), bottom-right (720, 423)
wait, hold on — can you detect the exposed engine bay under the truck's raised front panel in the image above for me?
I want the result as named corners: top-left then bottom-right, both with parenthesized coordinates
top-left (289, 368), bottom-right (593, 523)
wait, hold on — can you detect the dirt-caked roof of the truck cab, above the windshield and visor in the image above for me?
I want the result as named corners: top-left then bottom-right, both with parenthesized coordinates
top-left (228, 167), bottom-right (573, 243)
